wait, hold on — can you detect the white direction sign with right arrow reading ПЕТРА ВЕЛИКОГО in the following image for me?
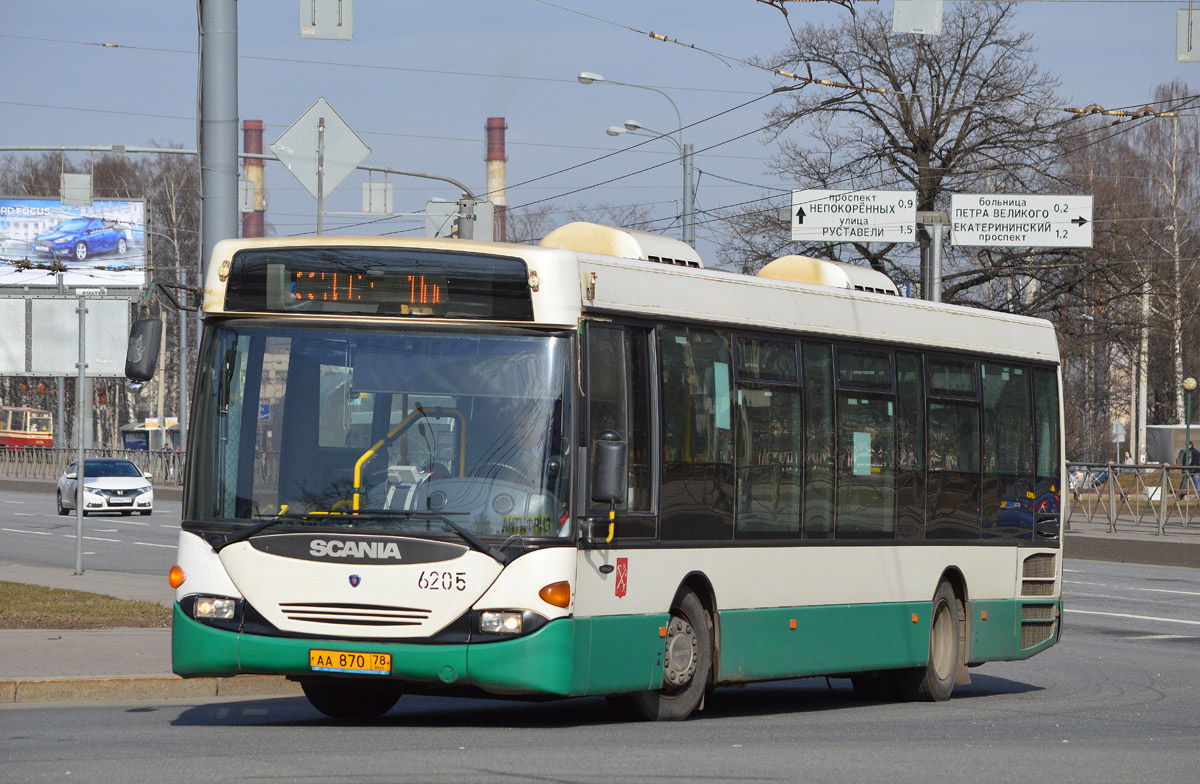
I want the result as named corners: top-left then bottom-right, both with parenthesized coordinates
top-left (950, 193), bottom-right (1092, 247)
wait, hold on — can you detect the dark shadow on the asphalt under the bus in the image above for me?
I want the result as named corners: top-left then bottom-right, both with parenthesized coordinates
top-left (172, 674), bottom-right (1043, 729)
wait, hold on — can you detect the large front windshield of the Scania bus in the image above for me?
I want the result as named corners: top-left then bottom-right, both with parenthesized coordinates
top-left (185, 321), bottom-right (570, 537)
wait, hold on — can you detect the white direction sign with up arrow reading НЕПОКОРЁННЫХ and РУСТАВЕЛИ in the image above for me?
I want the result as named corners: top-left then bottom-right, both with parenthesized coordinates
top-left (792, 191), bottom-right (917, 243)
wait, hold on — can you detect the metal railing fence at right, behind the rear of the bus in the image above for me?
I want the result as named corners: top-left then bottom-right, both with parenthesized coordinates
top-left (1066, 463), bottom-right (1200, 534)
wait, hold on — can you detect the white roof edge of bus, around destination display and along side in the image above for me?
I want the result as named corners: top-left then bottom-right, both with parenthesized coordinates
top-left (204, 237), bottom-right (1058, 363)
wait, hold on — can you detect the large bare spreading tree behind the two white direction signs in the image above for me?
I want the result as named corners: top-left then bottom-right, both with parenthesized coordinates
top-left (721, 2), bottom-right (1062, 301)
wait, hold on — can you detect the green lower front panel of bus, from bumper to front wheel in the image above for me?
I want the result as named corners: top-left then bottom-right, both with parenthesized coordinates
top-left (172, 604), bottom-right (666, 696)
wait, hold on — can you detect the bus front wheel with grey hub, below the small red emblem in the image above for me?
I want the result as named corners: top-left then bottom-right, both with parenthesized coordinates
top-left (630, 591), bottom-right (713, 722)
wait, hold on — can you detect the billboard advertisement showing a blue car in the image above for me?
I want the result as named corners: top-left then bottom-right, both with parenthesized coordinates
top-left (0, 197), bottom-right (146, 287)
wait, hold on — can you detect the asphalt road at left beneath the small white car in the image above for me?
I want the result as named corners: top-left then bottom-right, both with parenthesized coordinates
top-left (0, 487), bottom-right (181, 575)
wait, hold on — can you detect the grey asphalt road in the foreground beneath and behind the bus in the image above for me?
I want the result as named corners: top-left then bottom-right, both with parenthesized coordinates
top-left (0, 561), bottom-right (1200, 784)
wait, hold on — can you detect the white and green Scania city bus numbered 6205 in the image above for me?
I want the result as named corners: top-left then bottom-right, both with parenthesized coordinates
top-left (157, 223), bottom-right (1063, 719)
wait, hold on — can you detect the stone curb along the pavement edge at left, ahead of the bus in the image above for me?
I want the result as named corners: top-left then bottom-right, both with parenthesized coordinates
top-left (0, 675), bottom-right (302, 705)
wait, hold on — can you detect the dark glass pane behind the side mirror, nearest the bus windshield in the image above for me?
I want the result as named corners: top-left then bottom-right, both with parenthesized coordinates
top-left (587, 323), bottom-right (655, 538)
